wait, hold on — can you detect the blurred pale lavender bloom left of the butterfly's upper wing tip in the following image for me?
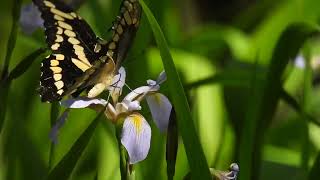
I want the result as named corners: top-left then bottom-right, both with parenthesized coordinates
top-left (19, 3), bottom-right (43, 34)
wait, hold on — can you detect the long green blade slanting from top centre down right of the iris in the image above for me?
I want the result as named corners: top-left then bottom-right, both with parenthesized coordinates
top-left (140, 0), bottom-right (211, 179)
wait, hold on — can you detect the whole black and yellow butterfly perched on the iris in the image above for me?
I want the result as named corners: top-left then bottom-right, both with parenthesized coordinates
top-left (33, 0), bottom-right (141, 102)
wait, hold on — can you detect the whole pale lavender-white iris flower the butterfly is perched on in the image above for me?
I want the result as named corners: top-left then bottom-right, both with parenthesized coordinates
top-left (52, 67), bottom-right (172, 164)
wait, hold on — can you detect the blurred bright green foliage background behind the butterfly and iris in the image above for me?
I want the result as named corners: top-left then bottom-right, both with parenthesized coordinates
top-left (0, 0), bottom-right (320, 180)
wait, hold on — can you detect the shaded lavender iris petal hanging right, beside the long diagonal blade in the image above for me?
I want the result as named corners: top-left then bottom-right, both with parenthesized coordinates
top-left (146, 93), bottom-right (172, 132)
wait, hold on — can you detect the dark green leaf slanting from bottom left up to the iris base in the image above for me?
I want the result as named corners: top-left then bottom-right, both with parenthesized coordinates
top-left (47, 113), bottom-right (103, 180)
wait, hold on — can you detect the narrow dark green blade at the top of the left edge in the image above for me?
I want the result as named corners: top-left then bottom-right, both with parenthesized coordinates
top-left (0, 0), bottom-right (22, 79)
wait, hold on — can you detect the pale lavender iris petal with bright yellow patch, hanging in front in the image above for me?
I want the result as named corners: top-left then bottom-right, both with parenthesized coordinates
top-left (121, 113), bottom-right (151, 164)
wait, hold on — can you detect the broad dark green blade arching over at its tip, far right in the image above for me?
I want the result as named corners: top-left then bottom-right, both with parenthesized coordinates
top-left (239, 23), bottom-right (318, 179)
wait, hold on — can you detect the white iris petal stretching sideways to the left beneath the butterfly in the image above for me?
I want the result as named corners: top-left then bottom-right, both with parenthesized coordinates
top-left (60, 97), bottom-right (108, 108)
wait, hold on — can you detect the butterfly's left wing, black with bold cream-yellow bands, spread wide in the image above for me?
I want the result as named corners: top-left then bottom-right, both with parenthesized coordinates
top-left (33, 0), bottom-right (99, 102)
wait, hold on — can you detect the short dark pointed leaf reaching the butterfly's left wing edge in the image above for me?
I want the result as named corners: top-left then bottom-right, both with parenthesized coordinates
top-left (8, 48), bottom-right (46, 80)
